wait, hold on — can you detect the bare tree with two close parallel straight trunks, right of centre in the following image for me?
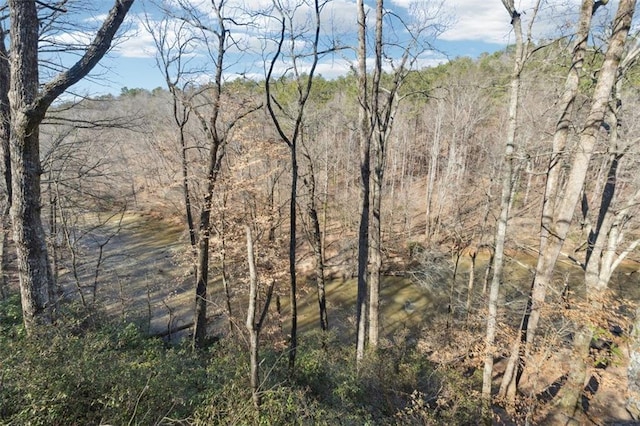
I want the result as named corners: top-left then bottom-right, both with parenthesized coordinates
top-left (356, 0), bottom-right (444, 361)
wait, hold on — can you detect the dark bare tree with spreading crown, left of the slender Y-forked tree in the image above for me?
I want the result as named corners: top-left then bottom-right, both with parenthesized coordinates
top-left (152, 0), bottom-right (261, 347)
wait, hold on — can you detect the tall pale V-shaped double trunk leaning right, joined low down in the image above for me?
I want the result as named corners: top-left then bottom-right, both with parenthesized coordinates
top-left (503, 0), bottom-right (636, 396)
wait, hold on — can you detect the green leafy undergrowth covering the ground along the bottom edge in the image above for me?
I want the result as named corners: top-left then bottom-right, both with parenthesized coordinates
top-left (0, 296), bottom-right (480, 425)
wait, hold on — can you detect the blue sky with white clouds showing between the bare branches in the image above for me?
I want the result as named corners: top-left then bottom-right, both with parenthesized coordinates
top-left (57, 0), bottom-right (592, 96)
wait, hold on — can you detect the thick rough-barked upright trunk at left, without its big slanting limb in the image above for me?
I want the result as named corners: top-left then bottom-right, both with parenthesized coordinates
top-left (9, 0), bottom-right (53, 331)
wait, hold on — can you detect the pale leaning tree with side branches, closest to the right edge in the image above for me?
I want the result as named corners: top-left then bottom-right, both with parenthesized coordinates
top-left (554, 31), bottom-right (640, 421)
